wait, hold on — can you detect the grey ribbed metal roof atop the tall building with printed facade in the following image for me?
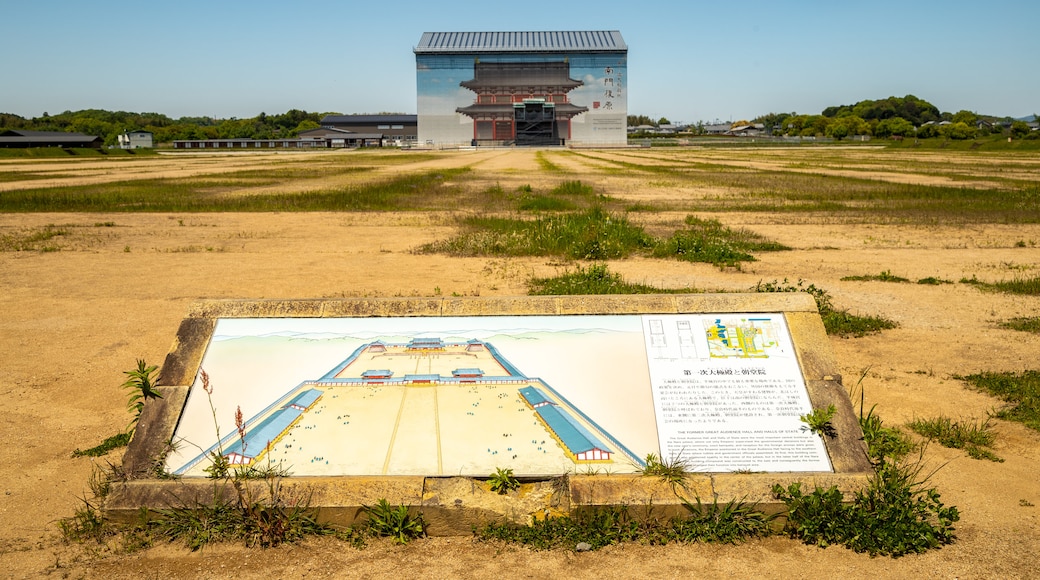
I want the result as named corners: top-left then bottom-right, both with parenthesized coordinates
top-left (415, 30), bottom-right (628, 54)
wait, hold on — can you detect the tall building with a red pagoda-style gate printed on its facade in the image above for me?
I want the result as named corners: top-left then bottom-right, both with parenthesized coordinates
top-left (415, 30), bottom-right (628, 147)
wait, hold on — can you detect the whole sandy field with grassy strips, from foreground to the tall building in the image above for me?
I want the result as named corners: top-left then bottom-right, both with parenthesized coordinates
top-left (0, 147), bottom-right (1040, 578)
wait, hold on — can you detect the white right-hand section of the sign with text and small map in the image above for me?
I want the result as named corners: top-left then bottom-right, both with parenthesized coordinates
top-left (643, 314), bottom-right (831, 472)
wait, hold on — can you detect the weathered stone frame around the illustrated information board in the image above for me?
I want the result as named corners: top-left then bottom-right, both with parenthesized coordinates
top-left (104, 293), bottom-right (874, 535)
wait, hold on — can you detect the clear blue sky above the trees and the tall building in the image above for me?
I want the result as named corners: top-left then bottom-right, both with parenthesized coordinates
top-left (0, 0), bottom-right (1040, 123)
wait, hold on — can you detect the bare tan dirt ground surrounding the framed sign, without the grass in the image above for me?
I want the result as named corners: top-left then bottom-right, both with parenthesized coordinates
top-left (0, 151), bottom-right (1040, 578)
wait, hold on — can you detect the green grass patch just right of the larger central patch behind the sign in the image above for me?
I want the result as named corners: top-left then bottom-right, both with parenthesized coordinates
top-left (653, 215), bottom-right (790, 268)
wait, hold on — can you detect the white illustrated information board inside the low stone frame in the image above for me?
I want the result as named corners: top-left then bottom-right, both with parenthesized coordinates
top-left (165, 313), bottom-right (832, 477)
